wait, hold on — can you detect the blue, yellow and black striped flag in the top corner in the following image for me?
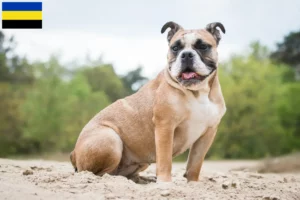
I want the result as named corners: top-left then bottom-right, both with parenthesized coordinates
top-left (2, 2), bottom-right (43, 29)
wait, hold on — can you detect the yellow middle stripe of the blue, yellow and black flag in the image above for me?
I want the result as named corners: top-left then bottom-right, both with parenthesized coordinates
top-left (2, 11), bottom-right (43, 20)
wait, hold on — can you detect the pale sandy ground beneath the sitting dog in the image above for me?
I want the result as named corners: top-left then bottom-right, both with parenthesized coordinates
top-left (0, 159), bottom-right (300, 200)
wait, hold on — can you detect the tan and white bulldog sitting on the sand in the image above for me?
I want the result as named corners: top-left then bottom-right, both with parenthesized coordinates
top-left (70, 22), bottom-right (226, 182)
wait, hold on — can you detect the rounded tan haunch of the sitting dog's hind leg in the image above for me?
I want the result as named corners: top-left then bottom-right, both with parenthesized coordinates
top-left (74, 126), bottom-right (123, 176)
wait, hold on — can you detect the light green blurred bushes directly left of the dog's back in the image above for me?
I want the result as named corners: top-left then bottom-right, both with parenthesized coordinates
top-left (22, 58), bottom-right (109, 152)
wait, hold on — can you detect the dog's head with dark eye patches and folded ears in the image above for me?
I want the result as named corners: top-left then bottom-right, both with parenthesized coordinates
top-left (161, 22), bottom-right (225, 90)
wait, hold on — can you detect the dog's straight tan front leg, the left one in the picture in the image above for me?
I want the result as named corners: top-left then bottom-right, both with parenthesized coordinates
top-left (155, 124), bottom-right (174, 182)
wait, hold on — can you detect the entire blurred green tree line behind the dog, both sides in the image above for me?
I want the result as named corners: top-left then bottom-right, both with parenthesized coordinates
top-left (0, 32), bottom-right (300, 158)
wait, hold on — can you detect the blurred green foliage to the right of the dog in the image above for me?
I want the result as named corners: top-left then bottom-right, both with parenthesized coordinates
top-left (210, 43), bottom-right (300, 158)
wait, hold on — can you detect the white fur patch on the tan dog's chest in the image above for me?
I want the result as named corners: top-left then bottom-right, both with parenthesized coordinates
top-left (183, 95), bottom-right (220, 149)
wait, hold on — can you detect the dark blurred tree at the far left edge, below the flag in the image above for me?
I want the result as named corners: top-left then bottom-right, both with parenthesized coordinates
top-left (0, 31), bottom-right (34, 156)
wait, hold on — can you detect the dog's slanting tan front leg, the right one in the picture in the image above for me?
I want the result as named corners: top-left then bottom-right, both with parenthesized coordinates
top-left (184, 127), bottom-right (217, 182)
